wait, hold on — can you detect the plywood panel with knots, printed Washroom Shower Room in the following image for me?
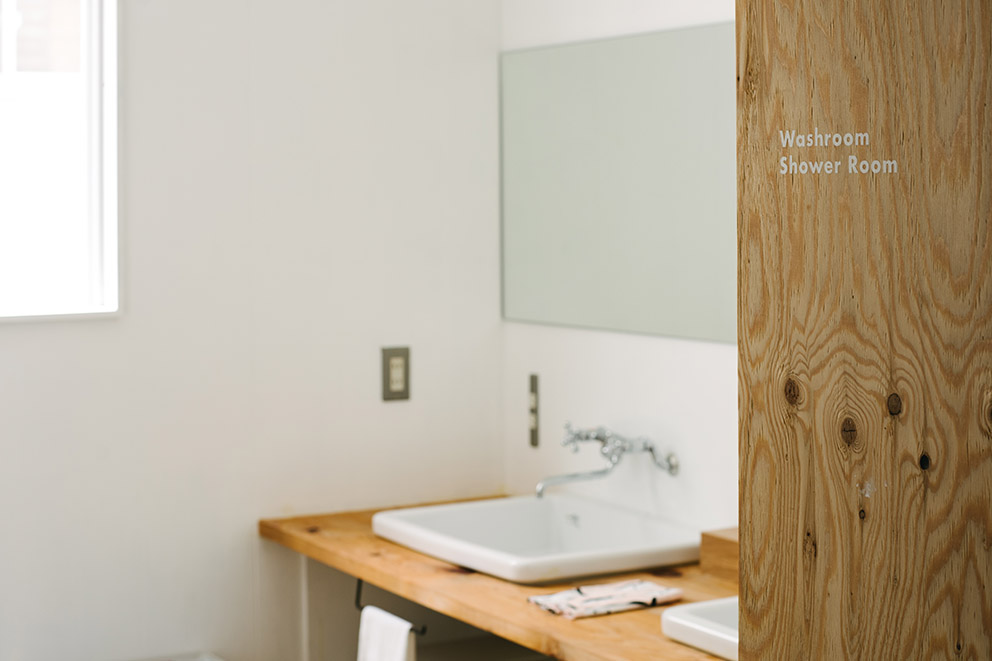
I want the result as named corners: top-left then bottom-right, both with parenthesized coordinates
top-left (737, 0), bottom-right (992, 659)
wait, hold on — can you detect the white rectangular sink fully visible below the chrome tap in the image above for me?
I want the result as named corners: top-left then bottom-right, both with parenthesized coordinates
top-left (372, 494), bottom-right (699, 583)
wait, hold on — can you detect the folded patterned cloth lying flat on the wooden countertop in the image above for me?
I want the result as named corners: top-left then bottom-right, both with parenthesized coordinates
top-left (528, 579), bottom-right (682, 620)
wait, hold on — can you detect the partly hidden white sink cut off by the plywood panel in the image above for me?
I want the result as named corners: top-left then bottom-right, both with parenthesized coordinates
top-left (661, 597), bottom-right (738, 661)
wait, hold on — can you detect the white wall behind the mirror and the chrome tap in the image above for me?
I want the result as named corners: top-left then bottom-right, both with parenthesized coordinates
top-left (501, 0), bottom-right (737, 529)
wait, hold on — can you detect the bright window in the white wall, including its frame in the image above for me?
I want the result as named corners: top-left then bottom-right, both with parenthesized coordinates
top-left (0, 0), bottom-right (117, 317)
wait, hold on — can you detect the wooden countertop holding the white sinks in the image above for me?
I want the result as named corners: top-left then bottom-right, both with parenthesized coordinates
top-left (258, 500), bottom-right (737, 661)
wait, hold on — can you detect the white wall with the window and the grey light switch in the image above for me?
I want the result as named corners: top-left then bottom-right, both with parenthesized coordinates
top-left (0, 0), bottom-right (502, 661)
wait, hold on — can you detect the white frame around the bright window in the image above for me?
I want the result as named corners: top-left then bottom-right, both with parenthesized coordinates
top-left (0, 0), bottom-right (120, 323)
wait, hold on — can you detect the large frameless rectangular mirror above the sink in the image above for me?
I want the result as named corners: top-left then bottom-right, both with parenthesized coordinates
top-left (501, 23), bottom-right (737, 342)
